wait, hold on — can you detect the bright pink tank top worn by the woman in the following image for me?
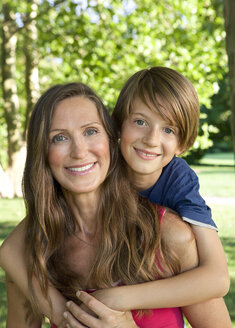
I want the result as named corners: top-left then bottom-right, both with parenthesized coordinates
top-left (51, 205), bottom-right (184, 328)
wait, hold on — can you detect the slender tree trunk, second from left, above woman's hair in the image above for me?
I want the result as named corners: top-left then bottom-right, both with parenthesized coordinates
top-left (24, 0), bottom-right (40, 138)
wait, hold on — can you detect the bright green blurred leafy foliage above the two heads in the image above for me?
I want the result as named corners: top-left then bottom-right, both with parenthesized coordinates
top-left (0, 0), bottom-right (231, 164)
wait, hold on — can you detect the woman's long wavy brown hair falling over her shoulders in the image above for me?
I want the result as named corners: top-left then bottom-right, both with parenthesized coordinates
top-left (23, 83), bottom-right (179, 320)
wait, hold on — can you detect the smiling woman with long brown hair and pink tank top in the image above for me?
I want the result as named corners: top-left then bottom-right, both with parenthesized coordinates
top-left (0, 84), bottom-right (231, 327)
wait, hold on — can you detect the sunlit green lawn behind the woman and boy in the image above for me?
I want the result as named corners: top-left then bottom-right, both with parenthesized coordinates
top-left (0, 152), bottom-right (235, 328)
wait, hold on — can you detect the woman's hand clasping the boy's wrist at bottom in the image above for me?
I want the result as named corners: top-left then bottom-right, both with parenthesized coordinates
top-left (64, 291), bottom-right (137, 328)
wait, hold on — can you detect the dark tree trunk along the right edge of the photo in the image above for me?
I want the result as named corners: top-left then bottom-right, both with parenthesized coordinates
top-left (224, 0), bottom-right (235, 154)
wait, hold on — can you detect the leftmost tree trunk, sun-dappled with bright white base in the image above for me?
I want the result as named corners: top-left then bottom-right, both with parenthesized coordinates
top-left (0, 3), bottom-right (25, 197)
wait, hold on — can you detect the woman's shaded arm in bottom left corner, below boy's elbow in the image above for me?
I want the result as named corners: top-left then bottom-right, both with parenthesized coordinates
top-left (6, 276), bottom-right (41, 328)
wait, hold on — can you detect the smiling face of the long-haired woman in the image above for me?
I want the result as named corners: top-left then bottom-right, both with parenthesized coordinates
top-left (48, 96), bottom-right (110, 194)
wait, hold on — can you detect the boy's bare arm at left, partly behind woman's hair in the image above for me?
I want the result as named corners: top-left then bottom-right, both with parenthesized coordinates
top-left (0, 220), bottom-right (66, 327)
